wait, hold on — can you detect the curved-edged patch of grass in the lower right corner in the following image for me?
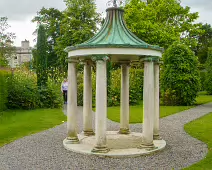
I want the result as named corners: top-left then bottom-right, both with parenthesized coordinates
top-left (184, 113), bottom-right (212, 170)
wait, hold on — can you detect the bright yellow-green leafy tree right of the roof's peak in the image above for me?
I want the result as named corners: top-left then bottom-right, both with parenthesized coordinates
top-left (125, 0), bottom-right (201, 49)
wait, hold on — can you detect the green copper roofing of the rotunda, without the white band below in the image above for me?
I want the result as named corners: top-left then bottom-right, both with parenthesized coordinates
top-left (67, 7), bottom-right (163, 51)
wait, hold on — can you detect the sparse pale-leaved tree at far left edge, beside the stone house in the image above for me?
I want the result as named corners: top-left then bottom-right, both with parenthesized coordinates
top-left (0, 17), bottom-right (15, 66)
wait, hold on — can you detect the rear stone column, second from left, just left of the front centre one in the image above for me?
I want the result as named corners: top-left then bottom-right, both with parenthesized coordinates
top-left (83, 61), bottom-right (94, 136)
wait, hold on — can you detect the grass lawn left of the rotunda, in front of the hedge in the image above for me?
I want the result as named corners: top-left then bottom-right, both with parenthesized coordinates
top-left (0, 109), bottom-right (66, 147)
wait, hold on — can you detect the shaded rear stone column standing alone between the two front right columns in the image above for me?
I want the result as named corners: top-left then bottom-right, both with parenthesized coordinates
top-left (119, 62), bottom-right (130, 134)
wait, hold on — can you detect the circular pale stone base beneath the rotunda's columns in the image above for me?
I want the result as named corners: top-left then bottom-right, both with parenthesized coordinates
top-left (63, 131), bottom-right (166, 158)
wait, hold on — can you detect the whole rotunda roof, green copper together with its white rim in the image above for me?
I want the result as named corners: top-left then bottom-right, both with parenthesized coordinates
top-left (65, 7), bottom-right (163, 60)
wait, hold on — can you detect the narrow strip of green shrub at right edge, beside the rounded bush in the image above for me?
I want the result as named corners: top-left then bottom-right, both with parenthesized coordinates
top-left (206, 47), bottom-right (212, 94)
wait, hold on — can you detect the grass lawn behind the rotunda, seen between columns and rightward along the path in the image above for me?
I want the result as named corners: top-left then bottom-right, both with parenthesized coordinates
top-left (107, 92), bottom-right (212, 123)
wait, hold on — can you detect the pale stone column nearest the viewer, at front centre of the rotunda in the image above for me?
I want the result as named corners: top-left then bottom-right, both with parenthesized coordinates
top-left (92, 57), bottom-right (109, 153)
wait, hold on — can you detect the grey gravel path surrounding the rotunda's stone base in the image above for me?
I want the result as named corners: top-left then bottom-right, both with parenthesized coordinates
top-left (0, 103), bottom-right (212, 170)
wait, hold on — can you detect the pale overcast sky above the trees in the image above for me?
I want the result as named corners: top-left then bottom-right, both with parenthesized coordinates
top-left (0, 0), bottom-right (212, 46)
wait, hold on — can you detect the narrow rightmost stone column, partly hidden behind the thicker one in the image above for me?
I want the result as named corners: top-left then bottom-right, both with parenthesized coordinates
top-left (153, 61), bottom-right (160, 140)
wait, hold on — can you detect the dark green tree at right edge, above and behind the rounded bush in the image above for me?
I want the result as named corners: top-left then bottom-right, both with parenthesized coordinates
top-left (196, 24), bottom-right (212, 64)
